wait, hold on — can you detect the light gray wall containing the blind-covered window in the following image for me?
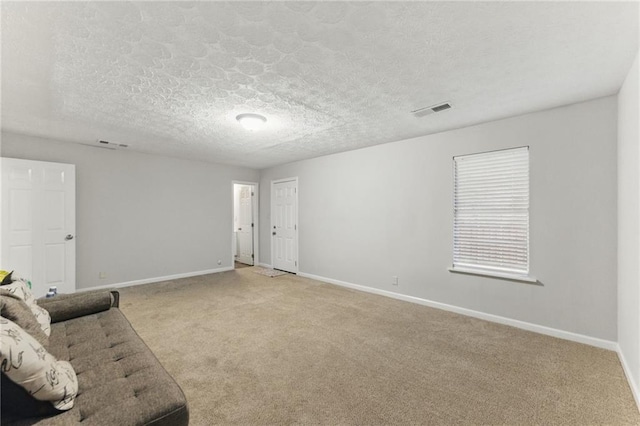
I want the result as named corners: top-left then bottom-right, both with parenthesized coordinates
top-left (260, 96), bottom-right (617, 341)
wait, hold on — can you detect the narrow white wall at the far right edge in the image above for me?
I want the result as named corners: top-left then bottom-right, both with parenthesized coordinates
top-left (618, 50), bottom-right (640, 404)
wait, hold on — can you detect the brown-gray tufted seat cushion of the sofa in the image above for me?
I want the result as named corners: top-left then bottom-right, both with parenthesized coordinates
top-left (9, 308), bottom-right (189, 425)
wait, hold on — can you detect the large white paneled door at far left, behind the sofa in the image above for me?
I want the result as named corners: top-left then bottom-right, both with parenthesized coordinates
top-left (0, 158), bottom-right (76, 297)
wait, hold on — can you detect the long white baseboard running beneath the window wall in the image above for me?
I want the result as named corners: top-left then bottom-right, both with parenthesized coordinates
top-left (298, 272), bottom-right (618, 351)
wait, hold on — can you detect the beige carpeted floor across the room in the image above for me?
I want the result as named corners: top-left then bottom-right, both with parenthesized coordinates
top-left (121, 268), bottom-right (640, 425)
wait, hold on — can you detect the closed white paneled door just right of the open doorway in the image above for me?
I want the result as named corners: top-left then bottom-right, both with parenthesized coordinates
top-left (271, 178), bottom-right (298, 273)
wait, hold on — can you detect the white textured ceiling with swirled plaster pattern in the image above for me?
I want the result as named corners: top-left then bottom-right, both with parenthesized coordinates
top-left (1, 1), bottom-right (638, 168)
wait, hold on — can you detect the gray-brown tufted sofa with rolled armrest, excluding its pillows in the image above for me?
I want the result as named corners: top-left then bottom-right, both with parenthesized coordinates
top-left (1, 291), bottom-right (189, 426)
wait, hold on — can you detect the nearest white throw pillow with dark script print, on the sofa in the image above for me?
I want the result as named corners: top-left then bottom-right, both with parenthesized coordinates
top-left (0, 317), bottom-right (78, 410)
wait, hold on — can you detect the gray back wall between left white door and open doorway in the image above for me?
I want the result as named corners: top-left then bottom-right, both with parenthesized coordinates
top-left (2, 132), bottom-right (258, 289)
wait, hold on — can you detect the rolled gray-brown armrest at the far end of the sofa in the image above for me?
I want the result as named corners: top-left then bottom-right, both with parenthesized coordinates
top-left (37, 290), bottom-right (119, 323)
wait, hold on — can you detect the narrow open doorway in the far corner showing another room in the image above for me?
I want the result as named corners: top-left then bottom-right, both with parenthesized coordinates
top-left (232, 182), bottom-right (258, 268)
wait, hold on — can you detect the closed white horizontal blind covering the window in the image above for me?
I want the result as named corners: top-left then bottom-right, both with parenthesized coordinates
top-left (452, 147), bottom-right (529, 277)
